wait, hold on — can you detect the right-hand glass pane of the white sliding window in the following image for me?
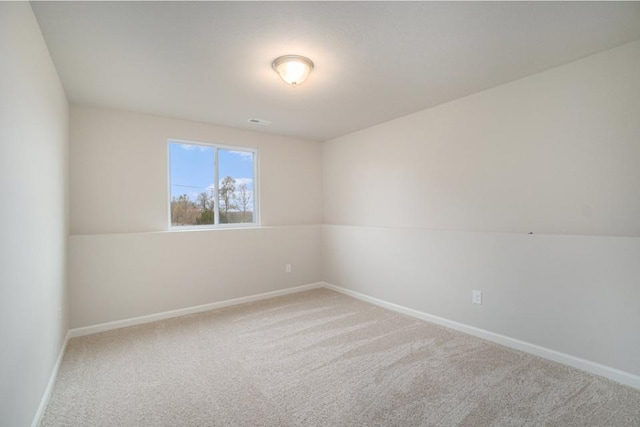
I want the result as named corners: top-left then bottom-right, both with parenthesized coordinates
top-left (218, 149), bottom-right (255, 224)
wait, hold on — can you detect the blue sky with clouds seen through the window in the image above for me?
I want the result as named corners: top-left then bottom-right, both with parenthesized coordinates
top-left (169, 142), bottom-right (253, 206)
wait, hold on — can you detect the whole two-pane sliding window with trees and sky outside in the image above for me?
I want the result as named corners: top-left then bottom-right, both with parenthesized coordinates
top-left (169, 140), bottom-right (258, 228)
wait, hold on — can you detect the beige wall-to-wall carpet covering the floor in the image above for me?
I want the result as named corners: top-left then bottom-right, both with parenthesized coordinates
top-left (42, 289), bottom-right (640, 426)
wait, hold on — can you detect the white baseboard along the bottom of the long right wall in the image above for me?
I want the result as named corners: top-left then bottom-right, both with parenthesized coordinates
top-left (324, 282), bottom-right (640, 389)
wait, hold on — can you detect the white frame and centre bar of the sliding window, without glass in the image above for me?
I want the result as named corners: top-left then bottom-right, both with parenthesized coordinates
top-left (167, 138), bottom-right (260, 231)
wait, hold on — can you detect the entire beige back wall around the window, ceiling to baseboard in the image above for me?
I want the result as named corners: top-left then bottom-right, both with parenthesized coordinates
top-left (69, 106), bottom-right (322, 328)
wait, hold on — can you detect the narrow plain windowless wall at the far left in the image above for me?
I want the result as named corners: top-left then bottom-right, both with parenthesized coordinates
top-left (0, 2), bottom-right (68, 426)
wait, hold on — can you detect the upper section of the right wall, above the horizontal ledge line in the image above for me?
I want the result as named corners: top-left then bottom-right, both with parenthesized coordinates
top-left (323, 41), bottom-right (640, 236)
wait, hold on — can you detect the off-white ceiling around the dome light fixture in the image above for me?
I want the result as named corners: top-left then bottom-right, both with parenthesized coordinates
top-left (32, 2), bottom-right (640, 141)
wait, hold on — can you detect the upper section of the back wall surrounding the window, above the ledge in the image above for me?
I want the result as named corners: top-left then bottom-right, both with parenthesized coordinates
top-left (70, 106), bottom-right (322, 234)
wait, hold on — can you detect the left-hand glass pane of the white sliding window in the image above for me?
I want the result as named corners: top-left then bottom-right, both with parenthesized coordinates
top-left (169, 142), bottom-right (215, 226)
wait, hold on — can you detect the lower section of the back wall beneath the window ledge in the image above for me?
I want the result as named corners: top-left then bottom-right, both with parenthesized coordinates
top-left (69, 225), bottom-right (321, 328)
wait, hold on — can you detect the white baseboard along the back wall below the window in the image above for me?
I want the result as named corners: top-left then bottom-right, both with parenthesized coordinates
top-left (69, 282), bottom-right (324, 338)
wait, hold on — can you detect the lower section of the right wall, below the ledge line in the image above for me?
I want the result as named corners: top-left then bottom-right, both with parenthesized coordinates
top-left (322, 225), bottom-right (640, 375)
